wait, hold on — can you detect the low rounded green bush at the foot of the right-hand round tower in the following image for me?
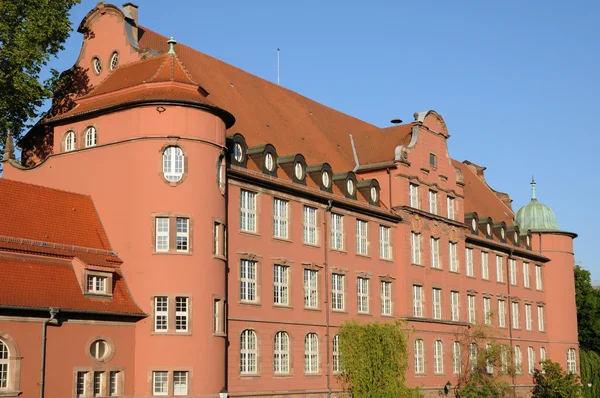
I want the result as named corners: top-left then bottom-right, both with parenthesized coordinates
top-left (533, 360), bottom-right (582, 398)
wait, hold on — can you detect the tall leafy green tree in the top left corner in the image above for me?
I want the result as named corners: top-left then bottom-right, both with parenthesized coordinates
top-left (0, 0), bottom-right (80, 143)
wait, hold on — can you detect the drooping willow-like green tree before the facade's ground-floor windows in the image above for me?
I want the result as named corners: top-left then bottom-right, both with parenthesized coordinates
top-left (339, 321), bottom-right (420, 398)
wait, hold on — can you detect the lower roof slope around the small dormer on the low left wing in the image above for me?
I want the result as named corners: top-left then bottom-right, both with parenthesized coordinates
top-left (0, 255), bottom-right (144, 315)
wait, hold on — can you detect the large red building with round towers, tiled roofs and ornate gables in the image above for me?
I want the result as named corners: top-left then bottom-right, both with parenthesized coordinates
top-left (0, 3), bottom-right (578, 397)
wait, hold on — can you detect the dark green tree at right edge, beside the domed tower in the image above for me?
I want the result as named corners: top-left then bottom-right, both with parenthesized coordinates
top-left (574, 266), bottom-right (600, 352)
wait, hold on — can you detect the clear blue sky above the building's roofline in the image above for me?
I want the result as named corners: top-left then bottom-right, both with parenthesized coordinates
top-left (43, 0), bottom-right (600, 279)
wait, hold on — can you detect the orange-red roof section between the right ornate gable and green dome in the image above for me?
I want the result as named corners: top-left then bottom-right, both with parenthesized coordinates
top-left (452, 159), bottom-right (515, 226)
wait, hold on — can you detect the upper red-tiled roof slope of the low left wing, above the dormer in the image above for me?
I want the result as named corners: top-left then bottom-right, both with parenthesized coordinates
top-left (0, 178), bottom-right (112, 250)
